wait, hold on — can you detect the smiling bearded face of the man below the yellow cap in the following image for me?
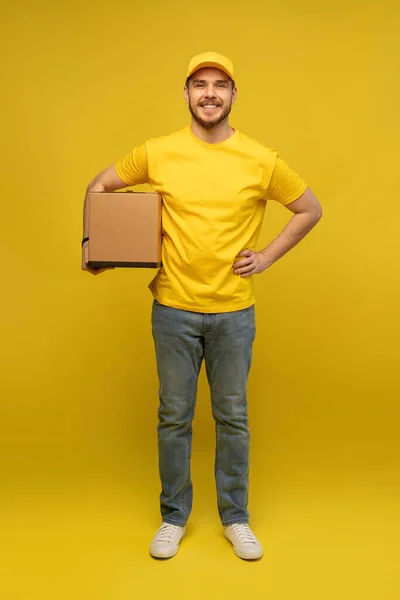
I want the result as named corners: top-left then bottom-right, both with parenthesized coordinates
top-left (185, 67), bottom-right (237, 130)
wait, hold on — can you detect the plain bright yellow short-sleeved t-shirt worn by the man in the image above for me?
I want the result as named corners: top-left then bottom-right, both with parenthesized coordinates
top-left (115, 125), bottom-right (307, 313)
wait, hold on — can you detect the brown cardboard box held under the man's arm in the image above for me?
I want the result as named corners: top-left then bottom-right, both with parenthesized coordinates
top-left (88, 191), bottom-right (162, 268)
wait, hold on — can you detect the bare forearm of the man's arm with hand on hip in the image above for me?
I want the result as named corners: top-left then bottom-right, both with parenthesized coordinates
top-left (261, 213), bottom-right (321, 267)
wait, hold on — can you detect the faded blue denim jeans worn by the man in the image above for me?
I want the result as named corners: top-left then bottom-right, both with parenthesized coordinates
top-left (152, 300), bottom-right (255, 526)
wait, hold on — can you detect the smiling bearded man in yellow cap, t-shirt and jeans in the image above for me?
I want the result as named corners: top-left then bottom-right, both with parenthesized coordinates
top-left (82, 52), bottom-right (322, 559)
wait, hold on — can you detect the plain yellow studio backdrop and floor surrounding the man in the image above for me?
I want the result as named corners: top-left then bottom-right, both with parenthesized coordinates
top-left (0, 0), bottom-right (400, 600)
